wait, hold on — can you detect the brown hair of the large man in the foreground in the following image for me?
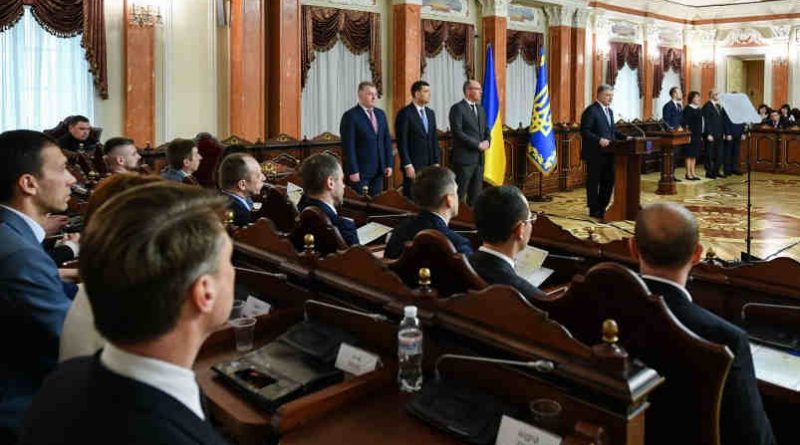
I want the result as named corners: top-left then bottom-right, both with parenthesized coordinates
top-left (80, 181), bottom-right (227, 345)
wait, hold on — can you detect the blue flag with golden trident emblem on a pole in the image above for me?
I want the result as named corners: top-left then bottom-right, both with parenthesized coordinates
top-left (528, 49), bottom-right (557, 176)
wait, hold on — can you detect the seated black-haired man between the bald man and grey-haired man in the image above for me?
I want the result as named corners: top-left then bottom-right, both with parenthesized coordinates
top-left (469, 185), bottom-right (545, 301)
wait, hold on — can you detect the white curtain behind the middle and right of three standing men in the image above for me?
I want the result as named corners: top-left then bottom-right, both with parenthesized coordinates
top-left (422, 48), bottom-right (467, 130)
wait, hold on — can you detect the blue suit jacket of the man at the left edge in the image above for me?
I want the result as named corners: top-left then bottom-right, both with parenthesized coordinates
top-left (0, 207), bottom-right (77, 430)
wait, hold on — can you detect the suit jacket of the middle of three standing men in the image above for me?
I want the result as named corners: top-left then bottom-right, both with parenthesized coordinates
top-left (394, 102), bottom-right (439, 170)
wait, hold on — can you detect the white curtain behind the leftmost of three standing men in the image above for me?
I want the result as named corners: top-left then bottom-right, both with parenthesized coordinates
top-left (300, 40), bottom-right (372, 139)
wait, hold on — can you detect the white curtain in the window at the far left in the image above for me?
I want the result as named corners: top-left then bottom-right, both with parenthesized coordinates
top-left (0, 6), bottom-right (94, 131)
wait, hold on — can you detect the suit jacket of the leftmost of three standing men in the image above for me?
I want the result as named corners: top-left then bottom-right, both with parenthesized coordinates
top-left (339, 105), bottom-right (394, 180)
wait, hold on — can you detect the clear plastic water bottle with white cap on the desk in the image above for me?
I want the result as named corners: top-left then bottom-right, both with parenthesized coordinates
top-left (397, 306), bottom-right (422, 392)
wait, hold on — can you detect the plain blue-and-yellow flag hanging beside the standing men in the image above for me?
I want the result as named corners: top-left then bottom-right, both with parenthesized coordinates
top-left (481, 43), bottom-right (506, 185)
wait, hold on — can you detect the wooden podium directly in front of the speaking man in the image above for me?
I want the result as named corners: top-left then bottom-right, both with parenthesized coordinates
top-left (602, 137), bottom-right (659, 221)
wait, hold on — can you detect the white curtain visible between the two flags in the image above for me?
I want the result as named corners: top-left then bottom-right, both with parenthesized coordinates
top-left (505, 55), bottom-right (536, 128)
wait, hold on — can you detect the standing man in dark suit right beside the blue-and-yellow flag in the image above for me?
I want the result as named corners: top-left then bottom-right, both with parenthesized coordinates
top-left (450, 80), bottom-right (491, 207)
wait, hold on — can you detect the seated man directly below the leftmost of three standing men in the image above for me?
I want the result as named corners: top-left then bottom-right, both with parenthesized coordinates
top-left (297, 153), bottom-right (359, 246)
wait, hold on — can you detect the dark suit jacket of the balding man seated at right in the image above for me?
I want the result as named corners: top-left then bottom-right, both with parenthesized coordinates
top-left (644, 278), bottom-right (775, 445)
